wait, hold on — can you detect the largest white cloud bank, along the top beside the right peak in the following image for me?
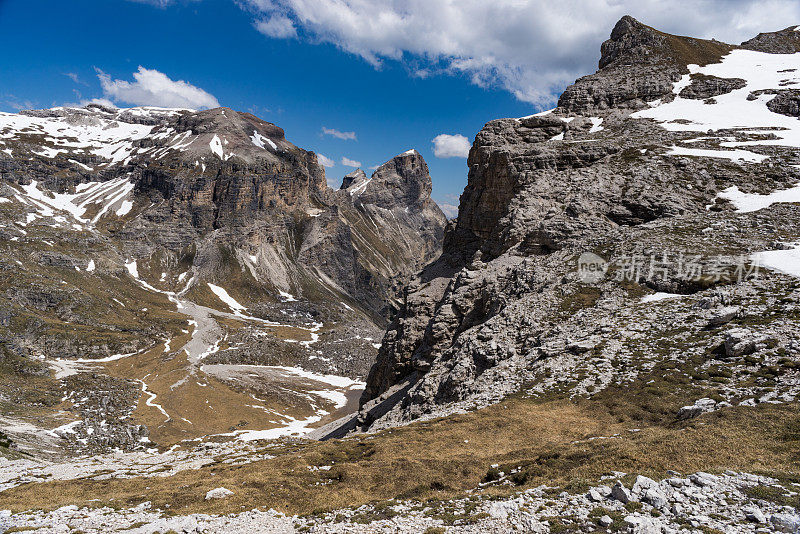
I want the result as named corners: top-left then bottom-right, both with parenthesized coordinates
top-left (238, 0), bottom-right (800, 105)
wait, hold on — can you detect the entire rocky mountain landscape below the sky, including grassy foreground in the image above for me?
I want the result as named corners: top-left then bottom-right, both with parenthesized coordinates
top-left (0, 16), bottom-right (800, 534)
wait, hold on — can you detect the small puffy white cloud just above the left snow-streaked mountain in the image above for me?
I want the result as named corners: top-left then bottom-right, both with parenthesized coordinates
top-left (97, 66), bottom-right (219, 109)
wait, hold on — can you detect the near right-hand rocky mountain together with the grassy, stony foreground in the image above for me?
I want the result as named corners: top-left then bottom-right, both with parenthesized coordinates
top-left (0, 17), bottom-right (800, 534)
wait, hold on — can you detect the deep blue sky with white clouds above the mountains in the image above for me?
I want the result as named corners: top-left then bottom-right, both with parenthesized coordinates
top-left (0, 0), bottom-right (800, 216)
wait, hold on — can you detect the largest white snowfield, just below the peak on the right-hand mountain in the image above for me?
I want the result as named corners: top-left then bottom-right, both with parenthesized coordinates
top-left (632, 50), bottom-right (800, 157)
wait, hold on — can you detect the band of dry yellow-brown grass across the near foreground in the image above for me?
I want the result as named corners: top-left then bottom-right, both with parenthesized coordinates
top-left (0, 398), bottom-right (800, 513)
